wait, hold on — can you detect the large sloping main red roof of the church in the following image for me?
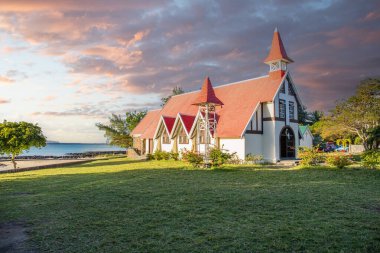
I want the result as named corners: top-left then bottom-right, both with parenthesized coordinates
top-left (131, 76), bottom-right (283, 139)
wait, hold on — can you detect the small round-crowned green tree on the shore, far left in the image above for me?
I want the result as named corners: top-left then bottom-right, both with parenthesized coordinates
top-left (0, 121), bottom-right (46, 169)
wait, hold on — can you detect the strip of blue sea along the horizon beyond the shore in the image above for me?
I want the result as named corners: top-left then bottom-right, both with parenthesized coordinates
top-left (22, 143), bottom-right (126, 156)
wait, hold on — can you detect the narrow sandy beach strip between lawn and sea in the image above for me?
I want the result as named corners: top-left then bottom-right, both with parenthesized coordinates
top-left (0, 158), bottom-right (93, 173)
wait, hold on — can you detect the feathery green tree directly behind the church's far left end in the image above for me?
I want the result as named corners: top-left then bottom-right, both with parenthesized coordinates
top-left (96, 111), bottom-right (146, 148)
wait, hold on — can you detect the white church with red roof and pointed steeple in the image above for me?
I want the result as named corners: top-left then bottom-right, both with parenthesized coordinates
top-left (131, 29), bottom-right (302, 162)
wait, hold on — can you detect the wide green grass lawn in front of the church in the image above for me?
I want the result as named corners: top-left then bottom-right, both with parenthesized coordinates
top-left (0, 158), bottom-right (380, 253)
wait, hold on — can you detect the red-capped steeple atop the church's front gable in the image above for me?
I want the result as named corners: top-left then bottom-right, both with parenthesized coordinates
top-left (264, 27), bottom-right (293, 78)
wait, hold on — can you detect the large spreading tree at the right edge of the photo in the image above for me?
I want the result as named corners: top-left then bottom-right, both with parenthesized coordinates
top-left (322, 78), bottom-right (380, 150)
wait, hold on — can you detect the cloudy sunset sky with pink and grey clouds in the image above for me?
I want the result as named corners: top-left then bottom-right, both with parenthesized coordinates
top-left (0, 0), bottom-right (380, 143)
